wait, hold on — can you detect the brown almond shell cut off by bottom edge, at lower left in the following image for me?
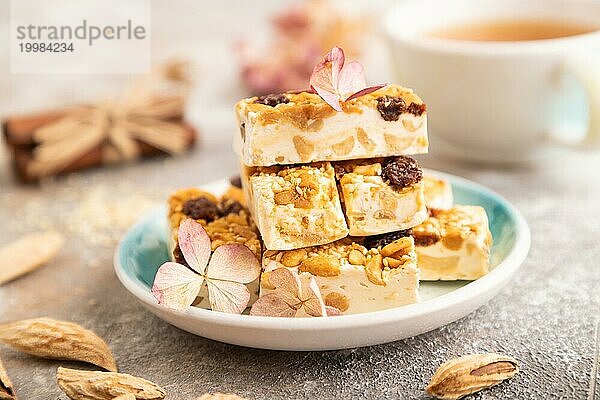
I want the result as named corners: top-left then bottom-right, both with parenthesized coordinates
top-left (56, 367), bottom-right (166, 400)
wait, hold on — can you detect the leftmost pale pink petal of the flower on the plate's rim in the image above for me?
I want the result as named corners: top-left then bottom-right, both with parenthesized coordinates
top-left (152, 262), bottom-right (204, 310)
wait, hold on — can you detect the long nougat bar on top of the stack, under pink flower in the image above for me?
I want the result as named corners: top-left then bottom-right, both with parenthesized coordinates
top-left (234, 85), bottom-right (429, 166)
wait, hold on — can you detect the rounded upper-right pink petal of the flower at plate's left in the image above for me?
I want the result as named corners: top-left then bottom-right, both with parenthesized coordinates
top-left (206, 243), bottom-right (260, 283)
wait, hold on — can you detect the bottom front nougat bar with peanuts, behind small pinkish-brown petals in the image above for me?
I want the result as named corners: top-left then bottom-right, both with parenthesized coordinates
top-left (260, 233), bottom-right (419, 314)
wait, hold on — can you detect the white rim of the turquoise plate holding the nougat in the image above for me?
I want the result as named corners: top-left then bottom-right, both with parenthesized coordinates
top-left (113, 170), bottom-right (531, 331)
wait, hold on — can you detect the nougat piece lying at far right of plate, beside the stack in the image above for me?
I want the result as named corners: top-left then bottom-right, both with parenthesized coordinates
top-left (413, 205), bottom-right (492, 281)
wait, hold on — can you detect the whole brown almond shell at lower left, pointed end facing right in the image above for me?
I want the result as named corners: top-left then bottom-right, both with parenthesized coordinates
top-left (0, 318), bottom-right (117, 371)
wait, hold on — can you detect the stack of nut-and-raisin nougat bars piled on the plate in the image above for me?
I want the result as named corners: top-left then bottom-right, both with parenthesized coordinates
top-left (166, 85), bottom-right (491, 314)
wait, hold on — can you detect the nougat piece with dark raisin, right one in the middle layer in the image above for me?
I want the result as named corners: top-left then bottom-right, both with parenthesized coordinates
top-left (335, 156), bottom-right (427, 236)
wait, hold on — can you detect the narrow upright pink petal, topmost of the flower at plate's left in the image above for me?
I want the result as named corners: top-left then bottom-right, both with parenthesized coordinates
top-left (178, 219), bottom-right (211, 275)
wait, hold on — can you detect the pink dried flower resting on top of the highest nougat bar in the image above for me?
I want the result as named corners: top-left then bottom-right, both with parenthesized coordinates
top-left (310, 47), bottom-right (385, 111)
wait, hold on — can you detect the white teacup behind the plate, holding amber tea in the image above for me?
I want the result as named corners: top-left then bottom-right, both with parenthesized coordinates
top-left (384, 0), bottom-right (600, 162)
